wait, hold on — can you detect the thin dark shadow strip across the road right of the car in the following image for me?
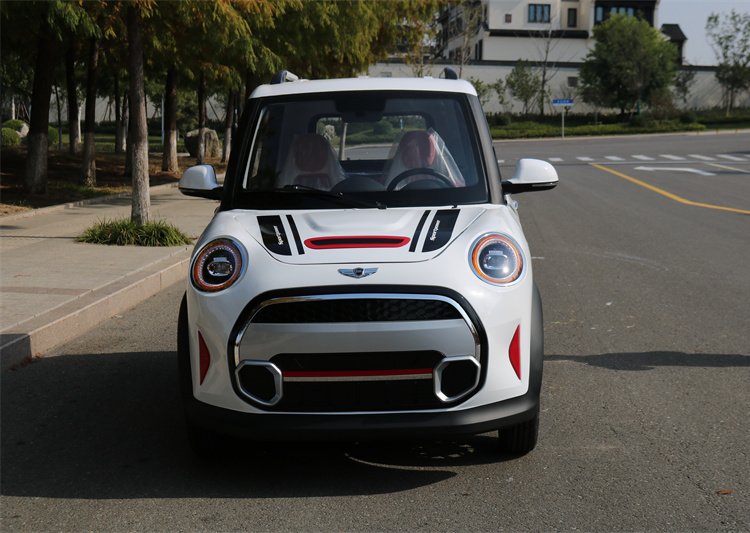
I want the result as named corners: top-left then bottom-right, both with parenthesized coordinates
top-left (544, 352), bottom-right (750, 370)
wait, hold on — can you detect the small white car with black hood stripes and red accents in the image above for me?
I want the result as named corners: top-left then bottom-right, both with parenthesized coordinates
top-left (178, 68), bottom-right (557, 453)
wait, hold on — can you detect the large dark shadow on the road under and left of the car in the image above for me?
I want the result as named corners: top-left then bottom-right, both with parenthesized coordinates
top-left (0, 352), bottom-right (508, 499)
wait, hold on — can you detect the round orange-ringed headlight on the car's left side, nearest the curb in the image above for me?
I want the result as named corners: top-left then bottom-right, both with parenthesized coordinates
top-left (191, 239), bottom-right (242, 292)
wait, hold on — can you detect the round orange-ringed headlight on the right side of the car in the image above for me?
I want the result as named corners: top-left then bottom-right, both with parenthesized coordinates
top-left (470, 233), bottom-right (523, 285)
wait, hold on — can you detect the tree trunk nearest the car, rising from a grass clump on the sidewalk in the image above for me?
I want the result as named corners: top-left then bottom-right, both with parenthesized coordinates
top-left (127, 4), bottom-right (151, 225)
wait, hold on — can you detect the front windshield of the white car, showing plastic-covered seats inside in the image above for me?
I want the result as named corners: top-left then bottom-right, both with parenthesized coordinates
top-left (235, 91), bottom-right (488, 209)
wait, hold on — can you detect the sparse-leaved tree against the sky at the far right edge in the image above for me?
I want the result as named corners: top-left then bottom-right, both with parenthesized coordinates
top-left (706, 9), bottom-right (750, 116)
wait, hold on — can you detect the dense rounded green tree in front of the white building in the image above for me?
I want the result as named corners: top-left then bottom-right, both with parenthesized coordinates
top-left (581, 14), bottom-right (677, 115)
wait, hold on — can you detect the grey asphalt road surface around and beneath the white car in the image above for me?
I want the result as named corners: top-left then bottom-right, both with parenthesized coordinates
top-left (0, 133), bottom-right (750, 531)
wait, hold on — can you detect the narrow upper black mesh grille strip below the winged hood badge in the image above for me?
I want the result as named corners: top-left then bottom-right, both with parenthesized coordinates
top-left (252, 298), bottom-right (462, 324)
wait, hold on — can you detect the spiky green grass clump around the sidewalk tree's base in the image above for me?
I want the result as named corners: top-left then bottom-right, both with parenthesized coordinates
top-left (78, 218), bottom-right (192, 246)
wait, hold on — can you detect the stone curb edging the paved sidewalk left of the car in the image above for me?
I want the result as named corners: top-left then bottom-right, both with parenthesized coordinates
top-left (0, 247), bottom-right (192, 371)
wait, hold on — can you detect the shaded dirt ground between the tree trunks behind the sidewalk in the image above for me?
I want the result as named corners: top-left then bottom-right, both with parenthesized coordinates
top-left (0, 147), bottom-right (226, 216)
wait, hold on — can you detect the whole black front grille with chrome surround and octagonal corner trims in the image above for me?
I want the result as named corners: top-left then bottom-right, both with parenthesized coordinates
top-left (234, 292), bottom-right (482, 413)
